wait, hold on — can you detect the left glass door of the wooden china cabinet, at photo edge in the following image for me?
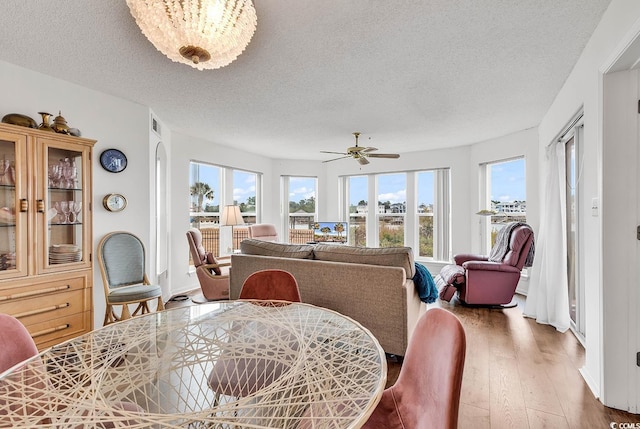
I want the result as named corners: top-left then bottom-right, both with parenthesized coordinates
top-left (0, 133), bottom-right (28, 279)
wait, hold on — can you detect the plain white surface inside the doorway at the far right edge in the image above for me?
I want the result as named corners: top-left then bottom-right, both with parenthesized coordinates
top-left (601, 71), bottom-right (638, 409)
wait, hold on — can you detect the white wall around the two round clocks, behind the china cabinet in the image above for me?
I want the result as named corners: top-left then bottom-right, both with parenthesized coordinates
top-left (0, 61), bottom-right (153, 327)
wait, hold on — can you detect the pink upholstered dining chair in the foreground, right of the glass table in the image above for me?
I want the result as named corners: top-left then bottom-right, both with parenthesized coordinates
top-left (362, 308), bottom-right (466, 429)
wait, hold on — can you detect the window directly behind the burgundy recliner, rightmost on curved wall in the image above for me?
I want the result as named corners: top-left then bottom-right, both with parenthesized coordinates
top-left (481, 158), bottom-right (527, 253)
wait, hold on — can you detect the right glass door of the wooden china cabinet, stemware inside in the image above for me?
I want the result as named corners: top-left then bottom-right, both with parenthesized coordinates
top-left (38, 142), bottom-right (89, 271)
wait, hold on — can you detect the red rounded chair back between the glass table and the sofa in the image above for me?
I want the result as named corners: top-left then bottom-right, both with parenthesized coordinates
top-left (240, 269), bottom-right (301, 302)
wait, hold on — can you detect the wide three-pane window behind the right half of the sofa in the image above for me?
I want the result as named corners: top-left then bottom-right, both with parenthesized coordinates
top-left (343, 168), bottom-right (451, 261)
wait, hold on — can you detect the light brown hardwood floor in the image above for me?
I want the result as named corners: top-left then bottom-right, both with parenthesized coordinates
top-left (167, 292), bottom-right (640, 429)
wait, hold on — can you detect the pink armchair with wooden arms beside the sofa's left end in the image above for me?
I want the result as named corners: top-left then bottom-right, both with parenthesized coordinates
top-left (187, 228), bottom-right (231, 301)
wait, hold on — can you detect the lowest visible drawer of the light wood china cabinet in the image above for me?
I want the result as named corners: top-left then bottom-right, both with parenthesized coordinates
top-left (27, 312), bottom-right (91, 350)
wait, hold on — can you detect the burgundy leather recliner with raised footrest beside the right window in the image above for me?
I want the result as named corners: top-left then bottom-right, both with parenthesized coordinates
top-left (436, 222), bottom-right (534, 305)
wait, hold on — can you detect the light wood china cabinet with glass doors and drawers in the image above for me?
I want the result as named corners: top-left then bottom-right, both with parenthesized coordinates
top-left (0, 124), bottom-right (96, 349)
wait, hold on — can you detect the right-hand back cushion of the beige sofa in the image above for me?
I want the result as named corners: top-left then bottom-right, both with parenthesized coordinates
top-left (313, 244), bottom-right (416, 279)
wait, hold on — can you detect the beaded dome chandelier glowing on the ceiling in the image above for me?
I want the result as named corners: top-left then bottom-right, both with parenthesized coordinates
top-left (127, 0), bottom-right (258, 70)
